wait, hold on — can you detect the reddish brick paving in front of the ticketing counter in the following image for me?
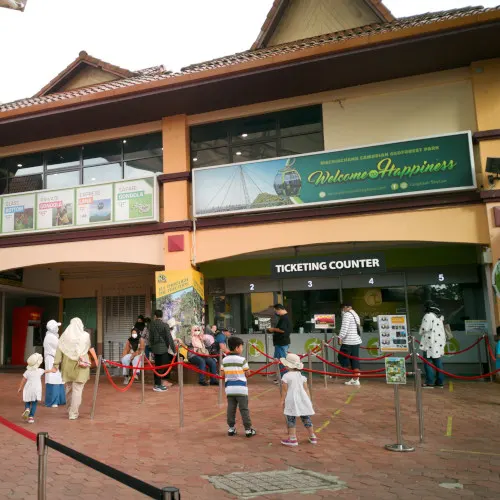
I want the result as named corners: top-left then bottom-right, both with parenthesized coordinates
top-left (0, 374), bottom-right (500, 500)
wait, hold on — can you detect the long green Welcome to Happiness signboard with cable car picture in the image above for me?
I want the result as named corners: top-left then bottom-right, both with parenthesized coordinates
top-left (193, 132), bottom-right (476, 217)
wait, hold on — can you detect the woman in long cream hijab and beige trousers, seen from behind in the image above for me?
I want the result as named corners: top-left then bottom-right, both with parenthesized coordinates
top-left (52, 318), bottom-right (96, 420)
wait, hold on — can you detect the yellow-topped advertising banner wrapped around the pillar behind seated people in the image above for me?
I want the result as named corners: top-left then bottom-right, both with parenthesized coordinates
top-left (155, 269), bottom-right (205, 343)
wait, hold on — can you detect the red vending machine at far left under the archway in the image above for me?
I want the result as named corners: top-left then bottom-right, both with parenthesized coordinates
top-left (12, 306), bottom-right (43, 365)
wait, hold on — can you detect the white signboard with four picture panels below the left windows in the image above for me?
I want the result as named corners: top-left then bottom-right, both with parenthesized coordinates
top-left (0, 177), bottom-right (159, 236)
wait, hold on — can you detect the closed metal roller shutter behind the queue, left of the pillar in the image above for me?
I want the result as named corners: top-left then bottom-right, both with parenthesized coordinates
top-left (103, 295), bottom-right (146, 361)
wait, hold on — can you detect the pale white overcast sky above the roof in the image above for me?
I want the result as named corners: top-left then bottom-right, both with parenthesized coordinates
top-left (0, 0), bottom-right (500, 103)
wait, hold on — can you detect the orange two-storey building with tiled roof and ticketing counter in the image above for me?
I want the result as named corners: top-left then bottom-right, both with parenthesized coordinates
top-left (0, 0), bottom-right (500, 364)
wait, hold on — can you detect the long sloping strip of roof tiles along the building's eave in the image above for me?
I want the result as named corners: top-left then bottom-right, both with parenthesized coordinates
top-left (0, 7), bottom-right (500, 117)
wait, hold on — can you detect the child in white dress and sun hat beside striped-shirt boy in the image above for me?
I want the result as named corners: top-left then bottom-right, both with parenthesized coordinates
top-left (280, 353), bottom-right (318, 446)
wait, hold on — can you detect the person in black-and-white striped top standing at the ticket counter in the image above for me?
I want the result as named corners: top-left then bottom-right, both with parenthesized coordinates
top-left (338, 303), bottom-right (362, 385)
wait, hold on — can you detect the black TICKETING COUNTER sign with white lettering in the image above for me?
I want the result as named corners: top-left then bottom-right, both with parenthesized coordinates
top-left (271, 253), bottom-right (386, 278)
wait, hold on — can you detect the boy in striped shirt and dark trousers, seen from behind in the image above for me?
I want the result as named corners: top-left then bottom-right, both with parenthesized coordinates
top-left (221, 337), bottom-right (256, 437)
